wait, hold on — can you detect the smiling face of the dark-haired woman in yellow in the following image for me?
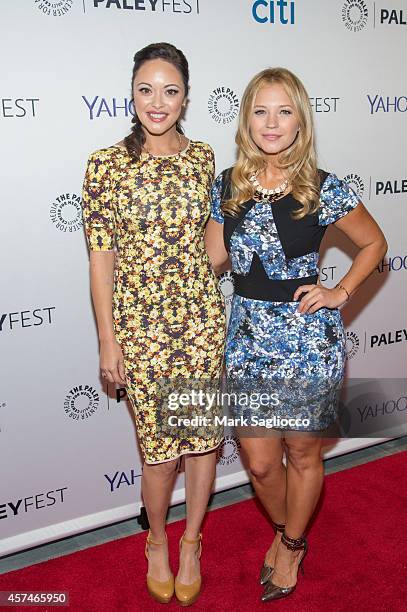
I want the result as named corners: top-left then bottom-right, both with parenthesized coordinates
top-left (133, 59), bottom-right (186, 136)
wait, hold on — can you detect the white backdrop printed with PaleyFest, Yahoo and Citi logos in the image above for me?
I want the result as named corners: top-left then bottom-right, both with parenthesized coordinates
top-left (0, 0), bottom-right (407, 554)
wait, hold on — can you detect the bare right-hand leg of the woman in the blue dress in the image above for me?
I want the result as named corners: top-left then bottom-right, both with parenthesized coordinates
top-left (272, 434), bottom-right (324, 586)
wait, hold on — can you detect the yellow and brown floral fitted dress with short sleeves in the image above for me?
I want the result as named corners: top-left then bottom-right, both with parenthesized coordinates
top-left (83, 141), bottom-right (225, 463)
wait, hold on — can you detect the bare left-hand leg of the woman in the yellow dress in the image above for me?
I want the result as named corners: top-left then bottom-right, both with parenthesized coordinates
top-left (141, 459), bottom-right (178, 581)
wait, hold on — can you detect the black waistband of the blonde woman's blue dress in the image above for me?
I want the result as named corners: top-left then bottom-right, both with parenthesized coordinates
top-left (233, 274), bottom-right (318, 302)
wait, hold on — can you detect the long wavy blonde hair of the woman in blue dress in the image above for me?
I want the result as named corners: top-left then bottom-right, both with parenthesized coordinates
top-left (222, 68), bottom-right (320, 219)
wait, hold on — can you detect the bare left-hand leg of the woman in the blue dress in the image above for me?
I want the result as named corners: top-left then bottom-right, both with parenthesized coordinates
top-left (240, 436), bottom-right (286, 566)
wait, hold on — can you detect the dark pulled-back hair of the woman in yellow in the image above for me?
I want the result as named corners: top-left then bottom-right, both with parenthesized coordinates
top-left (124, 43), bottom-right (189, 160)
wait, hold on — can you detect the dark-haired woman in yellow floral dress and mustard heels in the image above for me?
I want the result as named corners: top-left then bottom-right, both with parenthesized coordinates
top-left (83, 43), bottom-right (225, 604)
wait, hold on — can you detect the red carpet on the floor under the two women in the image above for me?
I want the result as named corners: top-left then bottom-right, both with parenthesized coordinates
top-left (0, 451), bottom-right (407, 612)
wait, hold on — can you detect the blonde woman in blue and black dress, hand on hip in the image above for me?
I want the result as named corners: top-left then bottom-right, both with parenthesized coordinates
top-left (206, 68), bottom-right (387, 601)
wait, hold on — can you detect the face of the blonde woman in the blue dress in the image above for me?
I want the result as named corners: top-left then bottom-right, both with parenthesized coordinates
top-left (249, 83), bottom-right (300, 155)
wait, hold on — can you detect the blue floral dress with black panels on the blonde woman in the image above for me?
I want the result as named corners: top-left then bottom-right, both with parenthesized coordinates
top-left (211, 169), bottom-right (359, 431)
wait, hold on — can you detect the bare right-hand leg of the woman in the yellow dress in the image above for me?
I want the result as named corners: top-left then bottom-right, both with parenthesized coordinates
top-left (177, 451), bottom-right (216, 584)
